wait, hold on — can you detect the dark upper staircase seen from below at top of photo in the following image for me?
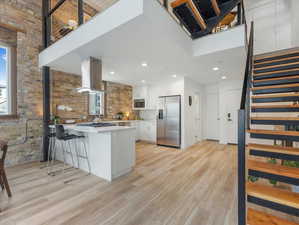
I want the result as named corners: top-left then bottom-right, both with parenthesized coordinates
top-left (171, 0), bottom-right (242, 39)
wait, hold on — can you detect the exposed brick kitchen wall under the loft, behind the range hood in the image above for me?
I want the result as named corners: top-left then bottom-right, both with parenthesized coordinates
top-left (51, 71), bottom-right (132, 119)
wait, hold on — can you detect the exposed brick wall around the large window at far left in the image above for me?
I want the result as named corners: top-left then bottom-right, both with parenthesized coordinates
top-left (0, 0), bottom-right (42, 165)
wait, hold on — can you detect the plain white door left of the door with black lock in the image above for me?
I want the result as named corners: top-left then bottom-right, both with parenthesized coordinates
top-left (206, 93), bottom-right (219, 140)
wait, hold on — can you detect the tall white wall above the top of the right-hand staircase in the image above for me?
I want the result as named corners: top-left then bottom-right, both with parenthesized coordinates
top-left (244, 0), bottom-right (297, 54)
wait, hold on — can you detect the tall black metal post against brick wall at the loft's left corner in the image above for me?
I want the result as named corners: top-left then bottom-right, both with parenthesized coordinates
top-left (42, 0), bottom-right (51, 161)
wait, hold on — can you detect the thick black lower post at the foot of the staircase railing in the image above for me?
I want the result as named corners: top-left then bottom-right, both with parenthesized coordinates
top-left (238, 109), bottom-right (246, 225)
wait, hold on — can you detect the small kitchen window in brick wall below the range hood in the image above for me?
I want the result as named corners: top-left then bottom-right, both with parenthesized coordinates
top-left (89, 92), bottom-right (105, 116)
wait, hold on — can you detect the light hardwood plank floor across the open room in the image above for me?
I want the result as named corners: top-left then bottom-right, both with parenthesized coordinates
top-left (0, 141), bottom-right (237, 225)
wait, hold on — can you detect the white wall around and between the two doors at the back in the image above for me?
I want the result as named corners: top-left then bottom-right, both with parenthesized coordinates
top-left (203, 80), bottom-right (243, 144)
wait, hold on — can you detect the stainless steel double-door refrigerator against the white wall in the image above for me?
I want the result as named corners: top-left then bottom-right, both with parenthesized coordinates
top-left (157, 95), bottom-right (181, 148)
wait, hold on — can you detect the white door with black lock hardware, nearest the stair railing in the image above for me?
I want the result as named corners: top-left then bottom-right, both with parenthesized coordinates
top-left (225, 90), bottom-right (241, 144)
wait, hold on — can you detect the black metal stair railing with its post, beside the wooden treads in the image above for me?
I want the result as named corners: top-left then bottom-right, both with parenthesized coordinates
top-left (238, 22), bottom-right (254, 225)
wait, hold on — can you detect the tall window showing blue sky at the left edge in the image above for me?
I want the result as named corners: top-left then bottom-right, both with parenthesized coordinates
top-left (0, 45), bottom-right (11, 115)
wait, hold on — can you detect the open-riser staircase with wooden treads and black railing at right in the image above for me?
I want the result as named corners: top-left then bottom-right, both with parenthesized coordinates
top-left (238, 24), bottom-right (299, 225)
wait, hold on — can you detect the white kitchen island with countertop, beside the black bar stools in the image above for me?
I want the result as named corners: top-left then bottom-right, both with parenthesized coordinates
top-left (57, 125), bottom-right (136, 181)
